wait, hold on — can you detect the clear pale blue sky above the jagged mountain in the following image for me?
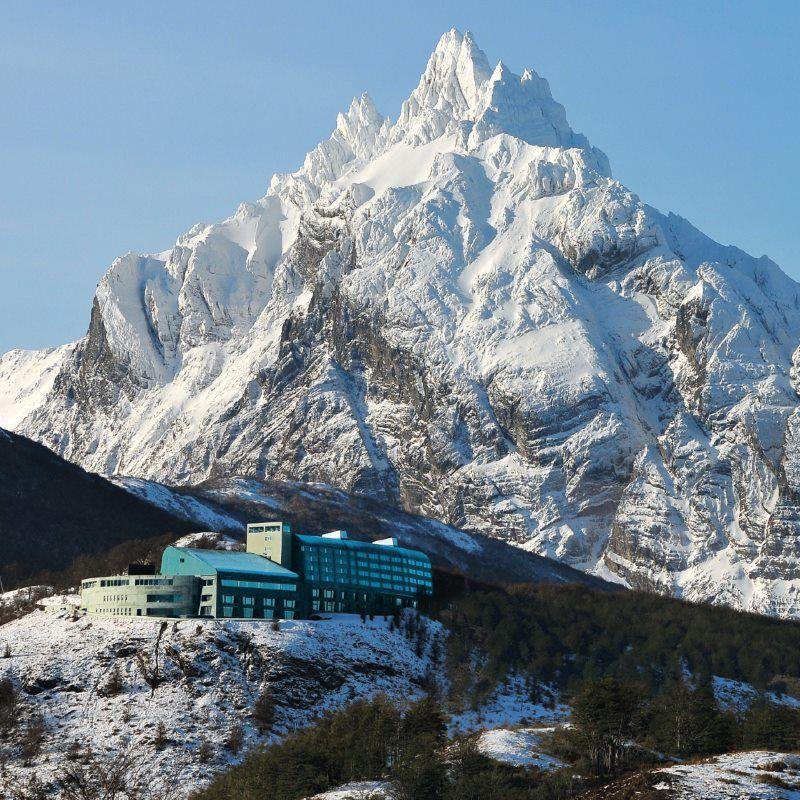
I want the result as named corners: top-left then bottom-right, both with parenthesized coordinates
top-left (0, 0), bottom-right (800, 352)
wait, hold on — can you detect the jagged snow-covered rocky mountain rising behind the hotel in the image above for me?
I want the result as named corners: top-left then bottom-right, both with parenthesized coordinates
top-left (0, 30), bottom-right (800, 616)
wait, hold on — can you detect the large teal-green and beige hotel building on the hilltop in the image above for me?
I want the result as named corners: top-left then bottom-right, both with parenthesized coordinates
top-left (81, 522), bottom-right (433, 619)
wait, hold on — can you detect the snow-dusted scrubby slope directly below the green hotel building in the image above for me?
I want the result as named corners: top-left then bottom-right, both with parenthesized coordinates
top-left (0, 611), bottom-right (441, 796)
